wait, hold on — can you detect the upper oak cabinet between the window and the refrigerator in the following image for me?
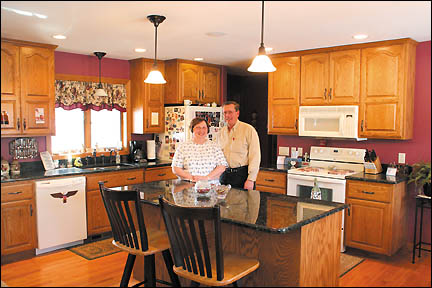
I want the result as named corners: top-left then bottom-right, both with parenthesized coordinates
top-left (129, 58), bottom-right (166, 134)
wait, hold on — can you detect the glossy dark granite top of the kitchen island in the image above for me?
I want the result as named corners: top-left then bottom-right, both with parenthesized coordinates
top-left (113, 180), bottom-right (348, 234)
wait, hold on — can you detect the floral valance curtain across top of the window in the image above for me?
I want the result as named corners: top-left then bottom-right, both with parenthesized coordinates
top-left (55, 80), bottom-right (126, 112)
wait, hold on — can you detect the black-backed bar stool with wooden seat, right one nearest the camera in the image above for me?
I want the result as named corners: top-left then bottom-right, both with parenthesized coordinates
top-left (159, 196), bottom-right (259, 287)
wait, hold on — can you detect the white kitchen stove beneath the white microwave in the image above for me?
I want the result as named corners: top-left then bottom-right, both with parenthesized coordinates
top-left (287, 146), bottom-right (366, 252)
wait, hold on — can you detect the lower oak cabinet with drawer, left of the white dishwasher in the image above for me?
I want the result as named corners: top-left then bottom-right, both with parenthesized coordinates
top-left (1, 181), bottom-right (37, 255)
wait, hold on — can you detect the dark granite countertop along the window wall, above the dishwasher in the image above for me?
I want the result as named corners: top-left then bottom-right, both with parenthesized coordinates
top-left (1, 161), bottom-right (171, 183)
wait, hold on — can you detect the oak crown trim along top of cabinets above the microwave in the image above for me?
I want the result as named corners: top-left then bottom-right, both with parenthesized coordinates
top-left (269, 38), bottom-right (418, 59)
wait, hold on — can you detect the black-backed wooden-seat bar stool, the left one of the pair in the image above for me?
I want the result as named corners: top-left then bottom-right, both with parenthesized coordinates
top-left (99, 181), bottom-right (180, 287)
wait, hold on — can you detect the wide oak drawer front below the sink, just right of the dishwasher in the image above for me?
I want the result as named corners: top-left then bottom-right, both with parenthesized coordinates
top-left (87, 170), bottom-right (144, 191)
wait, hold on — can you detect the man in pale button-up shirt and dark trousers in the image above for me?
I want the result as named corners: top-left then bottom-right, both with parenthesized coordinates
top-left (218, 101), bottom-right (261, 190)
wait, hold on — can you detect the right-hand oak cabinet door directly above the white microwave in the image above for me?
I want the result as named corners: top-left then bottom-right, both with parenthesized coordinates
top-left (327, 49), bottom-right (360, 105)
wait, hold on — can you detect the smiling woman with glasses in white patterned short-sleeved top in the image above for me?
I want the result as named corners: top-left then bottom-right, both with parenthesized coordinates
top-left (171, 118), bottom-right (228, 183)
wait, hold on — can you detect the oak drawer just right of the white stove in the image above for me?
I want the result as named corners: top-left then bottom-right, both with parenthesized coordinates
top-left (347, 180), bottom-right (393, 202)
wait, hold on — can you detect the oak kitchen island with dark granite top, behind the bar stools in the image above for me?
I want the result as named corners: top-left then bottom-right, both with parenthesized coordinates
top-left (114, 180), bottom-right (347, 286)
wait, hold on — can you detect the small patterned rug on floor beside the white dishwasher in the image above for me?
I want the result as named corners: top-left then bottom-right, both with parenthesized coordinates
top-left (67, 238), bottom-right (122, 260)
